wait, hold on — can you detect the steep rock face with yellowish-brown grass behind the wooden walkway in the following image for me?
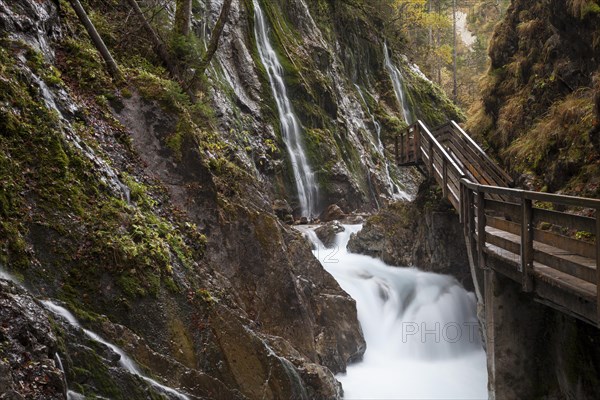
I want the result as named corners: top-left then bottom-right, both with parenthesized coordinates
top-left (468, 0), bottom-right (600, 196)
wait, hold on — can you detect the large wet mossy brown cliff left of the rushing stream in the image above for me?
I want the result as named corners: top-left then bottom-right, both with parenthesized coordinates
top-left (0, 0), bottom-right (460, 399)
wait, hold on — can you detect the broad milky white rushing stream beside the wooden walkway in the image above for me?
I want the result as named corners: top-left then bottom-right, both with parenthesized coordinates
top-left (303, 225), bottom-right (488, 399)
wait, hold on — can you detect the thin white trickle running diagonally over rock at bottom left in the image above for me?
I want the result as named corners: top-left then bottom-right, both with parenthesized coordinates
top-left (42, 300), bottom-right (190, 400)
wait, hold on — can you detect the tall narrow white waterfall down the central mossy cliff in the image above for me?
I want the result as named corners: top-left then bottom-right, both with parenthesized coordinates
top-left (254, 0), bottom-right (319, 218)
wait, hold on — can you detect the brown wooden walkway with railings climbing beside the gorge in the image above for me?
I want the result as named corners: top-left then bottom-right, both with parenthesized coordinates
top-left (389, 121), bottom-right (600, 326)
